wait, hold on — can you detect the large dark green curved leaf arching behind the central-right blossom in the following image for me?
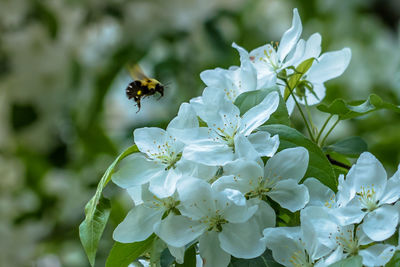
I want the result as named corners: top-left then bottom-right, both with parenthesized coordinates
top-left (261, 125), bottom-right (337, 192)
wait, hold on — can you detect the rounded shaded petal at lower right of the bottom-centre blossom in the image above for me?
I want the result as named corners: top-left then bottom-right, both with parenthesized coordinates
top-left (218, 219), bottom-right (266, 259)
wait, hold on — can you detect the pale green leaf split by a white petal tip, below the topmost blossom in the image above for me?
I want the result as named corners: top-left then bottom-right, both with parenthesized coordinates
top-left (235, 87), bottom-right (290, 125)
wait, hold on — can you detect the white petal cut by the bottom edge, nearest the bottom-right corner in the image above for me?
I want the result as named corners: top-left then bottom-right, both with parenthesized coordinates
top-left (358, 244), bottom-right (395, 266)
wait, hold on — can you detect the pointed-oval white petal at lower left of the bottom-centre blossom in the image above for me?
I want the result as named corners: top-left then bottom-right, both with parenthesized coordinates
top-left (154, 214), bottom-right (207, 247)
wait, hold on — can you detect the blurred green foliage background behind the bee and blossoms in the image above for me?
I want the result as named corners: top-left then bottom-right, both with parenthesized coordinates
top-left (0, 0), bottom-right (400, 267)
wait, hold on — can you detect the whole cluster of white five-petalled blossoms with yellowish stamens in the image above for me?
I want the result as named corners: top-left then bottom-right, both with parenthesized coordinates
top-left (108, 9), bottom-right (400, 266)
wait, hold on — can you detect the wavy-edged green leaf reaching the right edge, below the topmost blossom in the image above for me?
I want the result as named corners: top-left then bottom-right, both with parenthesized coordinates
top-left (317, 94), bottom-right (400, 120)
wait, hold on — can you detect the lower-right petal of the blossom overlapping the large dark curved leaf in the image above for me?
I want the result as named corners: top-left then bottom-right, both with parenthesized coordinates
top-left (268, 179), bottom-right (309, 212)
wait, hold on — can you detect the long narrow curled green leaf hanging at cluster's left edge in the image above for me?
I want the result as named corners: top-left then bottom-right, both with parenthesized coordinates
top-left (79, 145), bottom-right (139, 266)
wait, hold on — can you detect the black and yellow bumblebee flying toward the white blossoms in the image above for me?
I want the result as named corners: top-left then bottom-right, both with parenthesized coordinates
top-left (125, 65), bottom-right (165, 112)
